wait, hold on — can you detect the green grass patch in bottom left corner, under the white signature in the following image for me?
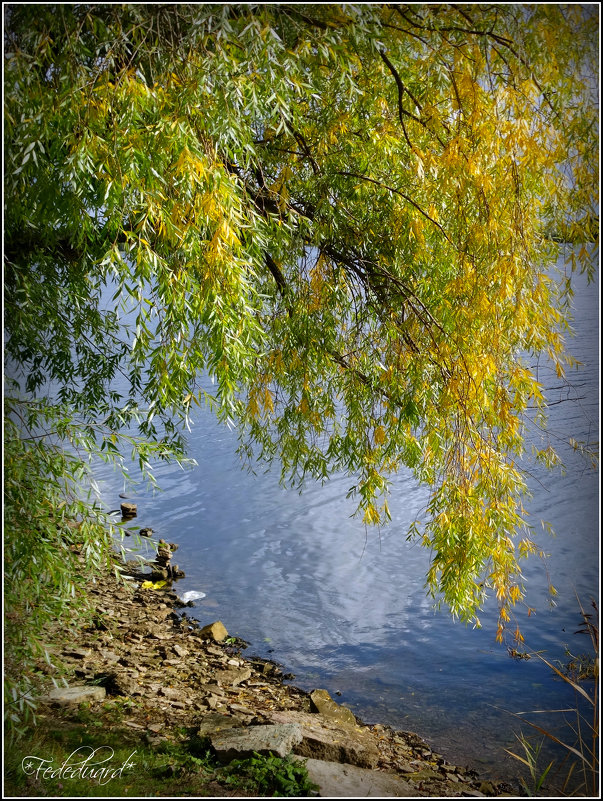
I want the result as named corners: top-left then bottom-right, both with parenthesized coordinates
top-left (4, 705), bottom-right (317, 798)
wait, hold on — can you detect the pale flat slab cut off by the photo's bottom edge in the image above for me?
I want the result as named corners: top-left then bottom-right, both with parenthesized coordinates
top-left (304, 759), bottom-right (424, 798)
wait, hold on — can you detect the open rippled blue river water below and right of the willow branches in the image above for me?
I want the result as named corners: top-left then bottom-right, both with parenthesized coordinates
top-left (92, 260), bottom-right (599, 778)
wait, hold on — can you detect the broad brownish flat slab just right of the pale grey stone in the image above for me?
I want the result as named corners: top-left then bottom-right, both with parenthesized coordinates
top-left (266, 710), bottom-right (379, 768)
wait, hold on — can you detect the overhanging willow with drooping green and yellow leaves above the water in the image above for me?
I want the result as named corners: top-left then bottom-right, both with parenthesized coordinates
top-left (4, 4), bottom-right (598, 688)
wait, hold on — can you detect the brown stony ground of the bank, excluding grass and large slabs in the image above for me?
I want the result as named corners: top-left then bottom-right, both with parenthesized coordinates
top-left (23, 552), bottom-right (520, 797)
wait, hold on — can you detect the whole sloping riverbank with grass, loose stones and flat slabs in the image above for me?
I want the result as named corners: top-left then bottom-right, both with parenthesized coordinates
top-left (5, 548), bottom-right (518, 797)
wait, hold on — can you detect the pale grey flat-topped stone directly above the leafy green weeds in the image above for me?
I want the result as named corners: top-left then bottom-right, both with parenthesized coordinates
top-left (211, 723), bottom-right (302, 764)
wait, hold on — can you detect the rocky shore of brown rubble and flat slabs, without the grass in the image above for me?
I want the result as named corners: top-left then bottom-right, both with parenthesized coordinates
top-left (31, 543), bottom-right (516, 797)
